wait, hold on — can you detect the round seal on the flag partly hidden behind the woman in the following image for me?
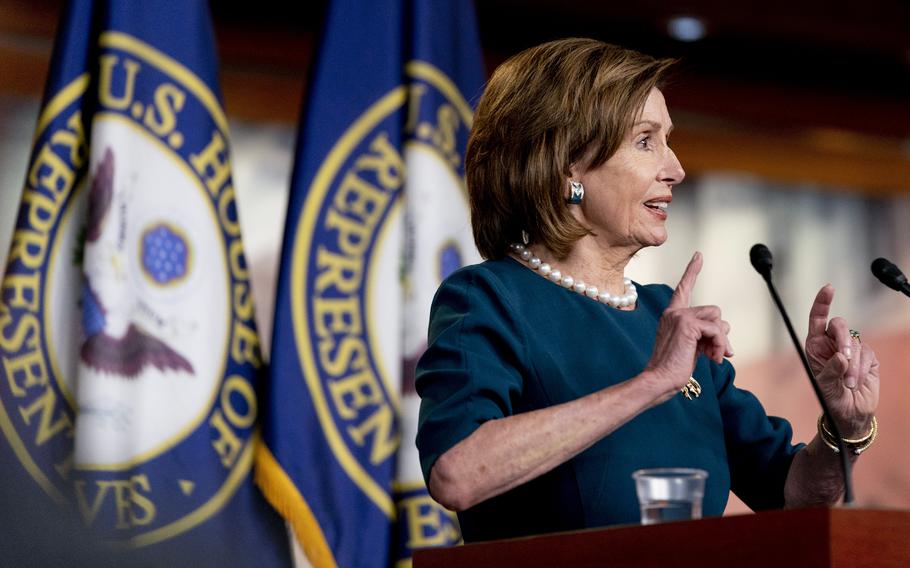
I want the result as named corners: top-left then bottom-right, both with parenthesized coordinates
top-left (291, 61), bottom-right (479, 548)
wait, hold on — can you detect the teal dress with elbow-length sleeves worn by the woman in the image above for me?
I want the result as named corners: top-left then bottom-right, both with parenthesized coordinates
top-left (416, 258), bottom-right (801, 542)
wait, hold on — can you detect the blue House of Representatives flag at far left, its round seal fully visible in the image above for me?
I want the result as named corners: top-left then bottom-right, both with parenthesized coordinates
top-left (0, 0), bottom-right (290, 566)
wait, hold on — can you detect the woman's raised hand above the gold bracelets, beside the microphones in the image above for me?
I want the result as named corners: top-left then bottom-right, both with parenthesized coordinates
top-left (806, 284), bottom-right (879, 438)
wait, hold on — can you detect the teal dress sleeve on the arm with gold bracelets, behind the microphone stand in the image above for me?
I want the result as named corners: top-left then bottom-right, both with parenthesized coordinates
top-left (714, 361), bottom-right (805, 511)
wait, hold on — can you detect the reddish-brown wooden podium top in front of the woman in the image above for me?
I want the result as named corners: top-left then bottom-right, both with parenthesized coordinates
top-left (414, 508), bottom-right (910, 568)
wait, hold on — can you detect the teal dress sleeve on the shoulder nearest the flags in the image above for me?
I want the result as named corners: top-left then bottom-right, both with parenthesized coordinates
top-left (416, 269), bottom-right (528, 483)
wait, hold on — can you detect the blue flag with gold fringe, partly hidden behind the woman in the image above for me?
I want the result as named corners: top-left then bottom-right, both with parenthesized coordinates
top-left (257, 0), bottom-right (484, 567)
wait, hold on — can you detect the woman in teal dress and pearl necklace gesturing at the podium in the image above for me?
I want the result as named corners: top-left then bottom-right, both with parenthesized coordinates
top-left (417, 39), bottom-right (879, 542)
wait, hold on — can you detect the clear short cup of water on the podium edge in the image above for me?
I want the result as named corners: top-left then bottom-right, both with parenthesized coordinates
top-left (632, 467), bottom-right (708, 525)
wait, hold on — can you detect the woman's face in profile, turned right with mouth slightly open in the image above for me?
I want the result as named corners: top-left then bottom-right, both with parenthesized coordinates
top-left (567, 88), bottom-right (686, 250)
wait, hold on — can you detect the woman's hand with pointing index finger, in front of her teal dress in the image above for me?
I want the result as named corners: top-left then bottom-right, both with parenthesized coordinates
top-left (645, 252), bottom-right (733, 402)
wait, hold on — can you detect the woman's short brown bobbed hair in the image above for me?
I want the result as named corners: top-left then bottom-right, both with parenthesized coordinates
top-left (465, 38), bottom-right (674, 259)
